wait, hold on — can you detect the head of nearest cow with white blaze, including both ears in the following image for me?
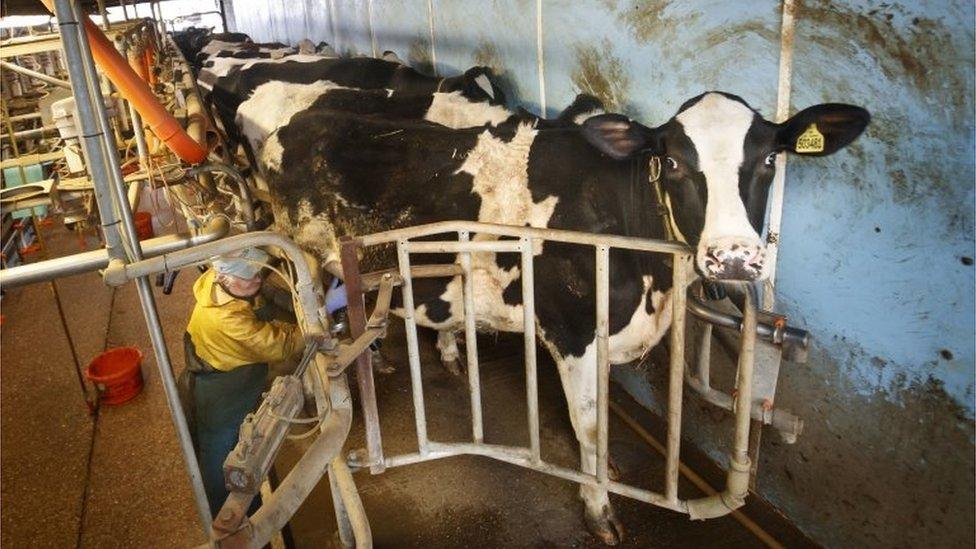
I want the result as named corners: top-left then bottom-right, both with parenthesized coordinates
top-left (583, 92), bottom-right (871, 281)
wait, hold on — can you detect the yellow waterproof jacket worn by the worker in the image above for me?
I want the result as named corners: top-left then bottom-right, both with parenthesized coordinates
top-left (186, 269), bottom-right (305, 372)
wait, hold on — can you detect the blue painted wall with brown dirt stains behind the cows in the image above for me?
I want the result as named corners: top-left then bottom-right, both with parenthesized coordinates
top-left (235, 0), bottom-right (976, 545)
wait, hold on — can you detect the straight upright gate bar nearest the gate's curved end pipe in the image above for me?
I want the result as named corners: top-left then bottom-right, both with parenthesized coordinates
top-left (664, 255), bottom-right (689, 503)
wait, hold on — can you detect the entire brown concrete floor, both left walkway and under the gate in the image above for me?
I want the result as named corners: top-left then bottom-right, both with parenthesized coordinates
top-left (0, 220), bottom-right (809, 548)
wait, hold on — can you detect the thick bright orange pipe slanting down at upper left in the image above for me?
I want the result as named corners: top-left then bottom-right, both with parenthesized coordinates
top-left (41, 0), bottom-right (207, 164)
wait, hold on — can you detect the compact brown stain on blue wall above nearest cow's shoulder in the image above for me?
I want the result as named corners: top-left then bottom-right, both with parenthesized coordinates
top-left (572, 40), bottom-right (630, 112)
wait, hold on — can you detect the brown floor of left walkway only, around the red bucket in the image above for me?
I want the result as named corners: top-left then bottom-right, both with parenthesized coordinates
top-left (0, 220), bottom-right (205, 548)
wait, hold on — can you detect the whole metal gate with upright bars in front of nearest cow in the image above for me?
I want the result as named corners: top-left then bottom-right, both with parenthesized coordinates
top-left (341, 221), bottom-right (805, 519)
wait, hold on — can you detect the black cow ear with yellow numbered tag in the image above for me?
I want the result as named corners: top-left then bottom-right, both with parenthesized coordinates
top-left (776, 103), bottom-right (871, 156)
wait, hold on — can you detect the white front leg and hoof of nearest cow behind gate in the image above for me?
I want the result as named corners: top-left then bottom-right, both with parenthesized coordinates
top-left (556, 345), bottom-right (624, 545)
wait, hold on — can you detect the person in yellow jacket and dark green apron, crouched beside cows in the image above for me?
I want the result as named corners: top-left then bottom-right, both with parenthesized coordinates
top-left (180, 248), bottom-right (305, 516)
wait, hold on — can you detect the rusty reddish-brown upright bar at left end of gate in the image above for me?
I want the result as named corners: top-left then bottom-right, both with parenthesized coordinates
top-left (339, 238), bottom-right (384, 474)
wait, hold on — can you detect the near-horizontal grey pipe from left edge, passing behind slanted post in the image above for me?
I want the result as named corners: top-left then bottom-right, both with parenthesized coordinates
top-left (0, 217), bottom-right (230, 289)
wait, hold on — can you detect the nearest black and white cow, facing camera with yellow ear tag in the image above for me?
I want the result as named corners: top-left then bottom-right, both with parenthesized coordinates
top-left (241, 88), bottom-right (870, 544)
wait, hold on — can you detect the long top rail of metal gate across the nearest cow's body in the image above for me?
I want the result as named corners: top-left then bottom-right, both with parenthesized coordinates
top-left (360, 221), bottom-right (689, 254)
